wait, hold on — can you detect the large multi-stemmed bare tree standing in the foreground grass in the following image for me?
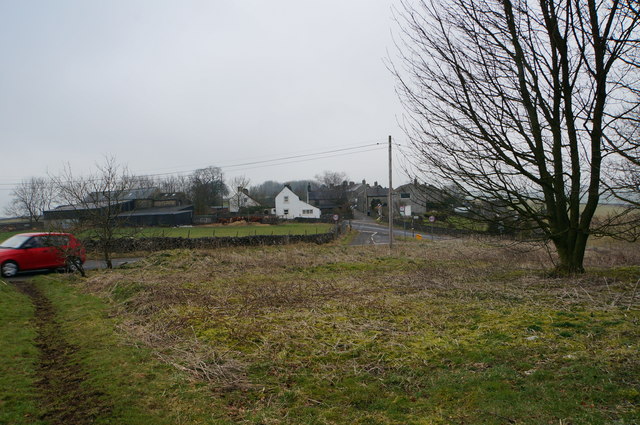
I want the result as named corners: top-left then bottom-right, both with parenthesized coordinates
top-left (392, 0), bottom-right (640, 273)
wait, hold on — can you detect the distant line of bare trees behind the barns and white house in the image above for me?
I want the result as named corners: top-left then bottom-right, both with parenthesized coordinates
top-left (5, 157), bottom-right (347, 224)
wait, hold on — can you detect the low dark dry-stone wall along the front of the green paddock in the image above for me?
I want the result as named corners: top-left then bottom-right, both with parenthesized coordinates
top-left (82, 233), bottom-right (336, 253)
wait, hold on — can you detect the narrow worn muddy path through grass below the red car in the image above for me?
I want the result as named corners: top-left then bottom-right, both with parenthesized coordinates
top-left (13, 280), bottom-right (110, 425)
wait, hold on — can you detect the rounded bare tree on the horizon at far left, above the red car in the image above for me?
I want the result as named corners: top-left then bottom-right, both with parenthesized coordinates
top-left (7, 177), bottom-right (55, 224)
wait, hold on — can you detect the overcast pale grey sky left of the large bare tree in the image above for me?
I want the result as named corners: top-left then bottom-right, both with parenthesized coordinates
top-left (0, 0), bottom-right (403, 215)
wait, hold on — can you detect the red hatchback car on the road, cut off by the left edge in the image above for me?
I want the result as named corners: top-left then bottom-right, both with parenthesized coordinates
top-left (0, 233), bottom-right (85, 277)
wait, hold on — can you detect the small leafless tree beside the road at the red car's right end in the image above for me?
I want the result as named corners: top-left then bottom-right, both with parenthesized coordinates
top-left (52, 157), bottom-right (135, 268)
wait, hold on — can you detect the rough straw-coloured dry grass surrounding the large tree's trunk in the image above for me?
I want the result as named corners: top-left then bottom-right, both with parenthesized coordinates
top-left (81, 240), bottom-right (640, 423)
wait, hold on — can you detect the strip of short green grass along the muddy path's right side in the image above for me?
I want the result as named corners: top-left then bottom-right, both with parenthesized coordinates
top-left (33, 278), bottom-right (228, 425)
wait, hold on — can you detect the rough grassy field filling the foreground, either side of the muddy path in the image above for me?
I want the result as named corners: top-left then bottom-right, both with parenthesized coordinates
top-left (0, 237), bottom-right (640, 425)
